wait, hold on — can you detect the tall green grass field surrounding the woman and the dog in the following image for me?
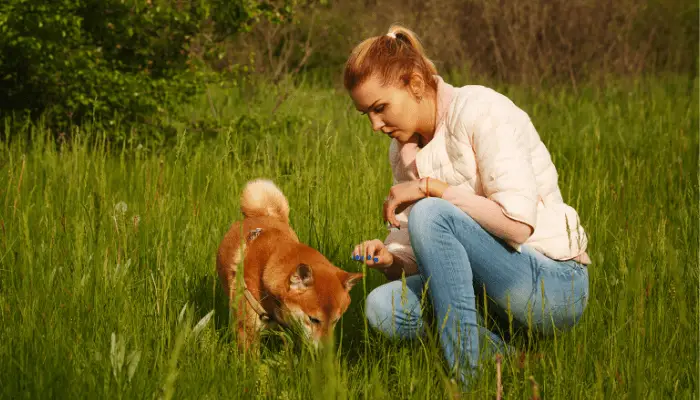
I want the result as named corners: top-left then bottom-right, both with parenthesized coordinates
top-left (0, 77), bottom-right (699, 399)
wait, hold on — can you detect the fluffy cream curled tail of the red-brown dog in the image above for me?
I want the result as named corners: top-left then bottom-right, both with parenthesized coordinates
top-left (241, 179), bottom-right (289, 224)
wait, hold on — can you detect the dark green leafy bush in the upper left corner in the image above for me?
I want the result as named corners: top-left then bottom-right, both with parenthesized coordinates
top-left (0, 0), bottom-right (296, 136)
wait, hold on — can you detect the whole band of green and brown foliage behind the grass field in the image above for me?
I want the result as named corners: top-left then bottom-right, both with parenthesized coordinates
top-left (0, 0), bottom-right (698, 138)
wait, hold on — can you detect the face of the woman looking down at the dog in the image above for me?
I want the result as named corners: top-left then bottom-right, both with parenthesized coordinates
top-left (350, 76), bottom-right (421, 143)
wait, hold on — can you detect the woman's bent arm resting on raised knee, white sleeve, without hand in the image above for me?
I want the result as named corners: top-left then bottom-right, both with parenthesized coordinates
top-left (442, 89), bottom-right (539, 249)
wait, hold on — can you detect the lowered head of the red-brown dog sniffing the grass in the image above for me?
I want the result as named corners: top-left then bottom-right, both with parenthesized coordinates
top-left (276, 263), bottom-right (363, 346)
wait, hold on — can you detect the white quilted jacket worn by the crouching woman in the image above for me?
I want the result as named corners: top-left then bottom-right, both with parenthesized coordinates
top-left (384, 76), bottom-right (589, 265)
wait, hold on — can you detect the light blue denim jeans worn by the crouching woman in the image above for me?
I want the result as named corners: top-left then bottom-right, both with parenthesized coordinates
top-left (366, 198), bottom-right (588, 380)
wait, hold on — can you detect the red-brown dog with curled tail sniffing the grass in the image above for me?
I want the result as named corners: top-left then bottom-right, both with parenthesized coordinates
top-left (216, 179), bottom-right (363, 350)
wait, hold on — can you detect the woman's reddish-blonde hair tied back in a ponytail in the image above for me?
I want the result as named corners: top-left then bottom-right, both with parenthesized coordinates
top-left (344, 25), bottom-right (437, 90)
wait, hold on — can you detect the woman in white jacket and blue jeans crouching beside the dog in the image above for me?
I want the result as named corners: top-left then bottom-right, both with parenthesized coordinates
top-left (344, 26), bottom-right (590, 380)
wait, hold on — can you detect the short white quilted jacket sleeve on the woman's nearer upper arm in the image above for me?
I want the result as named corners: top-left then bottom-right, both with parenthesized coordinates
top-left (451, 88), bottom-right (538, 231)
